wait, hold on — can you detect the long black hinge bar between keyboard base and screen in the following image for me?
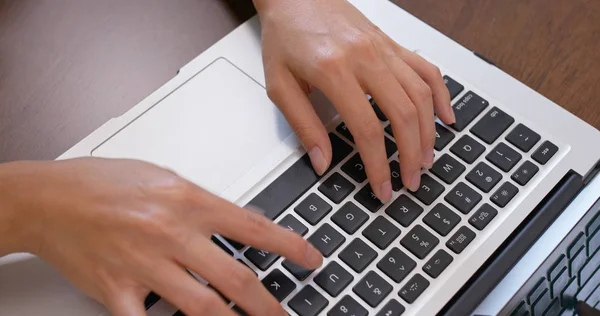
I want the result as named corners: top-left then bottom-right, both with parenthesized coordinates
top-left (438, 171), bottom-right (585, 315)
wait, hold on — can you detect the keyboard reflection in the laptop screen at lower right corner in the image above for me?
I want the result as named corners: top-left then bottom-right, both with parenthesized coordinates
top-left (501, 200), bottom-right (600, 316)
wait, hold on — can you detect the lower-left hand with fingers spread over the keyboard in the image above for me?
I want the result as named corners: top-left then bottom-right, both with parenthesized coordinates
top-left (0, 158), bottom-right (322, 316)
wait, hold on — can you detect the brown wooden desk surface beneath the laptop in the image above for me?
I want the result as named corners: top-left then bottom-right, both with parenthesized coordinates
top-left (0, 0), bottom-right (600, 161)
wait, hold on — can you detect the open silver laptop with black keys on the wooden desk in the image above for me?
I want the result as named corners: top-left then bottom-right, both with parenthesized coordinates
top-left (0, 0), bottom-right (600, 316)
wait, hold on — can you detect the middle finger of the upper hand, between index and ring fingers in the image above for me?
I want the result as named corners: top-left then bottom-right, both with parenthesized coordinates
top-left (364, 68), bottom-right (422, 191)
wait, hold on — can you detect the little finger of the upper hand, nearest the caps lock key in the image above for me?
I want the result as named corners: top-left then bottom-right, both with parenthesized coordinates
top-left (395, 44), bottom-right (456, 124)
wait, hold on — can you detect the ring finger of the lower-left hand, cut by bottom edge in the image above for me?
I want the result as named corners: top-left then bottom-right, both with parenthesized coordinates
top-left (147, 262), bottom-right (235, 316)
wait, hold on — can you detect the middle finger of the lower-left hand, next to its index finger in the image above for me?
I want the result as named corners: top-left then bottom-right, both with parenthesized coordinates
top-left (181, 235), bottom-right (287, 315)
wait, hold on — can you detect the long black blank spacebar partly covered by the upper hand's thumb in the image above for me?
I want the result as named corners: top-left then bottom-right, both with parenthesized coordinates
top-left (248, 134), bottom-right (352, 220)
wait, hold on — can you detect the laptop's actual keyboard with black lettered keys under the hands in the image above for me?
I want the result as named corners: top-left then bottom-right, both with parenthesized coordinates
top-left (156, 76), bottom-right (558, 316)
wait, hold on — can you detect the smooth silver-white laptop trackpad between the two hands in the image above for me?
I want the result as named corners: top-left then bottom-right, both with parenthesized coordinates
top-left (92, 58), bottom-right (292, 194)
